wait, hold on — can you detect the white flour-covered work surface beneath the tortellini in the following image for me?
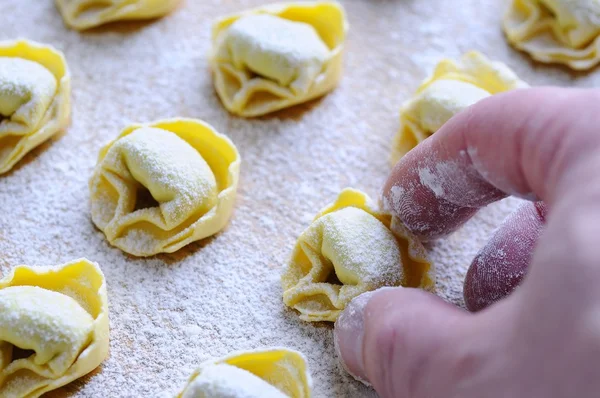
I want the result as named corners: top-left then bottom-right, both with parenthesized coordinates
top-left (0, 0), bottom-right (600, 397)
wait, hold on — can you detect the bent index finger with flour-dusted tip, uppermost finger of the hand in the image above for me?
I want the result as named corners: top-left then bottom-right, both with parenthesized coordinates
top-left (382, 88), bottom-right (595, 240)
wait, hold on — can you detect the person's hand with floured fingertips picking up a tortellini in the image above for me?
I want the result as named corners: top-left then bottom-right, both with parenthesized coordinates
top-left (335, 88), bottom-right (600, 398)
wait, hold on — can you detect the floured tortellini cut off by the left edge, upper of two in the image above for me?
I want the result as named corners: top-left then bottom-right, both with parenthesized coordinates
top-left (0, 40), bottom-right (71, 174)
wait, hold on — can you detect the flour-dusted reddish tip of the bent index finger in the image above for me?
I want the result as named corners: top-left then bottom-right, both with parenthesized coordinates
top-left (382, 127), bottom-right (506, 241)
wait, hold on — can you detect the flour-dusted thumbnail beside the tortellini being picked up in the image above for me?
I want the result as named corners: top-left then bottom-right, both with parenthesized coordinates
top-left (333, 288), bottom-right (398, 386)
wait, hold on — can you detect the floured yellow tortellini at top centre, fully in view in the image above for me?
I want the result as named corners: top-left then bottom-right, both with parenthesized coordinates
top-left (211, 1), bottom-right (347, 117)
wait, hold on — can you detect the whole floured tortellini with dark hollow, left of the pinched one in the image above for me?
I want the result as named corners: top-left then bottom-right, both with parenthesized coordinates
top-left (90, 119), bottom-right (240, 256)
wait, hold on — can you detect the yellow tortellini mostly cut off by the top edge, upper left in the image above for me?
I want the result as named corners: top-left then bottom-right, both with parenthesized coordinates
top-left (56, 0), bottom-right (181, 30)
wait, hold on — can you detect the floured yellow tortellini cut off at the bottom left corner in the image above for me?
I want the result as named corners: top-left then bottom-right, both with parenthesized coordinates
top-left (0, 259), bottom-right (109, 398)
